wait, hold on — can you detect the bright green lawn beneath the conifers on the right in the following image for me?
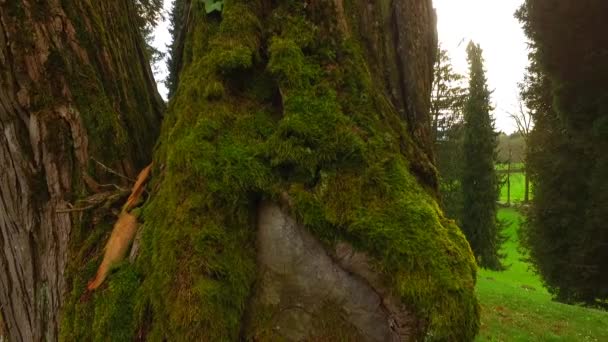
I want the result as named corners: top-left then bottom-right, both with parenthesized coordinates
top-left (476, 208), bottom-right (608, 341)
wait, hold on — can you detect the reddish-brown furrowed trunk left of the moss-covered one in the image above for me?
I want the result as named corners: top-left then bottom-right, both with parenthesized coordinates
top-left (0, 0), bottom-right (161, 341)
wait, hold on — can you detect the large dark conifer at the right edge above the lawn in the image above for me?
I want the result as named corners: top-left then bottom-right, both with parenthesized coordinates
top-left (517, 0), bottom-right (608, 304)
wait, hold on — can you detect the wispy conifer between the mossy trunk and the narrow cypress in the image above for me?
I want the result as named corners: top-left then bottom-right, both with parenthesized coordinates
top-left (431, 49), bottom-right (467, 220)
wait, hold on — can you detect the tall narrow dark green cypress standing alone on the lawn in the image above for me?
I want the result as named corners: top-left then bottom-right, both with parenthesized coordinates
top-left (461, 42), bottom-right (502, 269)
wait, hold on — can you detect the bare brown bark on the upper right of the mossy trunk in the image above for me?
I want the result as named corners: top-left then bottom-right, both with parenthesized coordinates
top-left (356, 0), bottom-right (438, 160)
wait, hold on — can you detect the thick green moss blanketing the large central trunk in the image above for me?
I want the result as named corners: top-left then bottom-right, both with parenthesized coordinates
top-left (63, 1), bottom-right (479, 340)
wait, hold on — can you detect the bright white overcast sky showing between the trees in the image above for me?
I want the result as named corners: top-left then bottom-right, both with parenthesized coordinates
top-left (153, 0), bottom-right (528, 134)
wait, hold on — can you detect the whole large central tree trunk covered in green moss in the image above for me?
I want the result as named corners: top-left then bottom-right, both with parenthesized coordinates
top-left (54, 0), bottom-right (479, 341)
